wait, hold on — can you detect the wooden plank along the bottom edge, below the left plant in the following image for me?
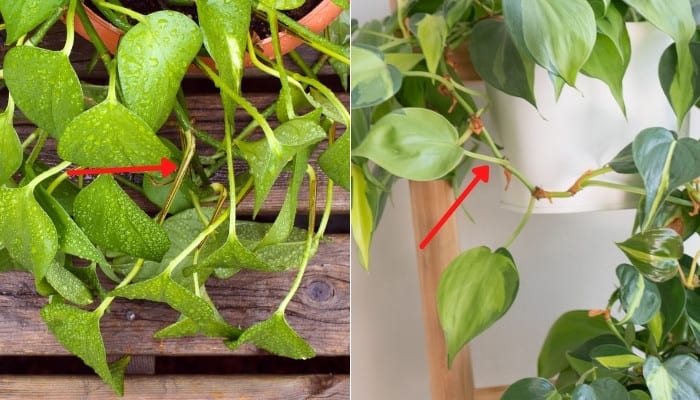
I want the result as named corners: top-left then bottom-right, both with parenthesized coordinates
top-left (0, 375), bottom-right (350, 400)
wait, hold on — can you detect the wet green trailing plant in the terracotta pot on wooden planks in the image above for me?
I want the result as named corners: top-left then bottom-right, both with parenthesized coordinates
top-left (0, 0), bottom-right (350, 394)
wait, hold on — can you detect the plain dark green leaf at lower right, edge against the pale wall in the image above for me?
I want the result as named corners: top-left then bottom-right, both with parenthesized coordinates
top-left (537, 310), bottom-right (610, 378)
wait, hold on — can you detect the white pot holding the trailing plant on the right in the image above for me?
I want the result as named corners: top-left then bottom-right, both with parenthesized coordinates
top-left (487, 22), bottom-right (687, 213)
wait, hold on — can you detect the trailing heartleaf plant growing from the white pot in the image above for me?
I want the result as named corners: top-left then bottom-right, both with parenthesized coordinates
top-left (351, 0), bottom-right (700, 399)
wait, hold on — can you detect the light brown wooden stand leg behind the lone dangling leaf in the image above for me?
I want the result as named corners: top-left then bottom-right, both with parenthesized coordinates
top-left (409, 181), bottom-right (474, 400)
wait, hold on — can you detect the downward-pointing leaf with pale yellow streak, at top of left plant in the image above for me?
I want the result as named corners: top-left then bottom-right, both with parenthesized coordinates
top-left (196, 0), bottom-right (253, 97)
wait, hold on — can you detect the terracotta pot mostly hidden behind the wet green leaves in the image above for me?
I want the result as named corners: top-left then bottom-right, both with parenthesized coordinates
top-left (75, 0), bottom-right (343, 66)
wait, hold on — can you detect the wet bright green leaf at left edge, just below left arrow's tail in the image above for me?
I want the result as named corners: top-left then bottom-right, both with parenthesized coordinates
top-left (0, 186), bottom-right (58, 282)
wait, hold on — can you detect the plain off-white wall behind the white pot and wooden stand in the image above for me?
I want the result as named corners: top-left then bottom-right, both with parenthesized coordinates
top-left (351, 0), bottom-right (696, 400)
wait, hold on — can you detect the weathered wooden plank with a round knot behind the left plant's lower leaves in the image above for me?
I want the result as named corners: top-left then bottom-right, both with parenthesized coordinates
top-left (0, 235), bottom-right (350, 354)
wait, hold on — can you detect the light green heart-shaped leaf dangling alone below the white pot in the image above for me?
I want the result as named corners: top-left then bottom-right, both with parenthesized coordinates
top-left (437, 247), bottom-right (519, 365)
